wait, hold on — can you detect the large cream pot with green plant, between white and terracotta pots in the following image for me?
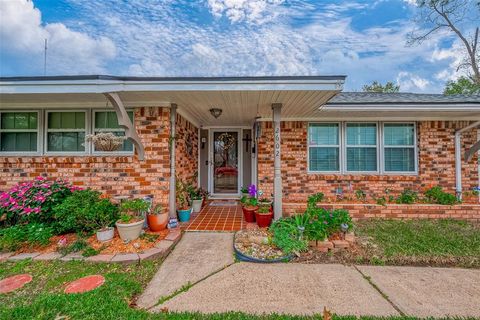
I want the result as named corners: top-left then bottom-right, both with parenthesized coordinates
top-left (115, 199), bottom-right (149, 241)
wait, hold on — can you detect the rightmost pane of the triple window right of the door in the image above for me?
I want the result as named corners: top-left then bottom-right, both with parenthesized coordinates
top-left (383, 123), bottom-right (415, 172)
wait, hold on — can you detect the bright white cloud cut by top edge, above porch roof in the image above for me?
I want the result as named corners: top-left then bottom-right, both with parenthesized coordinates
top-left (207, 0), bottom-right (284, 23)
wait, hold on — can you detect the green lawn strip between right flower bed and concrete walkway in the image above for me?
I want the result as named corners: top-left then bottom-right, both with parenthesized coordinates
top-left (356, 220), bottom-right (480, 267)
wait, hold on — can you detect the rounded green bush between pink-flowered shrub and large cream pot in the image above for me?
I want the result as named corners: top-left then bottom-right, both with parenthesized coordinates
top-left (53, 189), bottom-right (118, 234)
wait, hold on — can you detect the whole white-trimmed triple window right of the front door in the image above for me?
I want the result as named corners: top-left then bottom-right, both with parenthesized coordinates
top-left (308, 122), bottom-right (418, 174)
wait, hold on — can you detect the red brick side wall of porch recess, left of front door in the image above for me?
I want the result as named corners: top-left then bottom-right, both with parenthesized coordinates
top-left (175, 114), bottom-right (198, 184)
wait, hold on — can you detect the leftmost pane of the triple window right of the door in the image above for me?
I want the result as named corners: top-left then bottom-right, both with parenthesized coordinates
top-left (308, 123), bottom-right (340, 172)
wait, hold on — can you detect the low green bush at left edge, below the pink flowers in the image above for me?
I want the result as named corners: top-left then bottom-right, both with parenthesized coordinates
top-left (0, 223), bottom-right (53, 251)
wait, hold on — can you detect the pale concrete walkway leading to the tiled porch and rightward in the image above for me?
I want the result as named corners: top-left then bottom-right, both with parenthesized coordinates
top-left (138, 233), bottom-right (480, 317)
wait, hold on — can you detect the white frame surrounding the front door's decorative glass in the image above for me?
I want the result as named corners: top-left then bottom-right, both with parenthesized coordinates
top-left (208, 128), bottom-right (243, 199)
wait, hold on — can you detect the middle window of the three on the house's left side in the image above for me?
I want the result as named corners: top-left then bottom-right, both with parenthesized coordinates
top-left (47, 111), bottom-right (86, 152)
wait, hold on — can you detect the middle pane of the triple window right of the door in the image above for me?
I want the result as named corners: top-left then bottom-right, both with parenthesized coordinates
top-left (346, 123), bottom-right (377, 172)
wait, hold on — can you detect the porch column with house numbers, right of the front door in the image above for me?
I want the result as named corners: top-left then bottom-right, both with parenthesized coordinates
top-left (272, 103), bottom-right (283, 220)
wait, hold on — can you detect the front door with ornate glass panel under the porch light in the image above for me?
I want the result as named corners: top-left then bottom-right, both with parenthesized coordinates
top-left (210, 129), bottom-right (242, 197)
